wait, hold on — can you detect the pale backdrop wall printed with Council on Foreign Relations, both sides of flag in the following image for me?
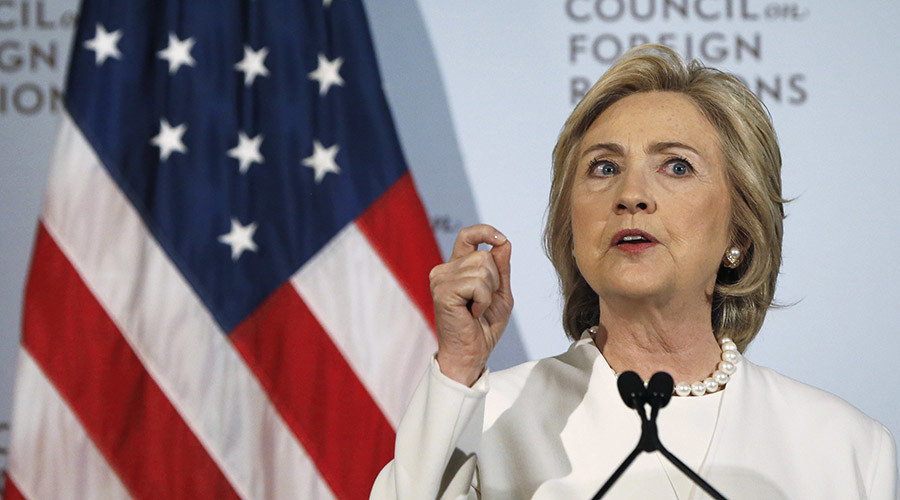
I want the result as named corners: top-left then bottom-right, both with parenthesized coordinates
top-left (0, 0), bottom-right (900, 478)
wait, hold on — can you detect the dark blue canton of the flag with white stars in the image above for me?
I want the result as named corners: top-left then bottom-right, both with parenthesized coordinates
top-left (66, 0), bottom-right (406, 332)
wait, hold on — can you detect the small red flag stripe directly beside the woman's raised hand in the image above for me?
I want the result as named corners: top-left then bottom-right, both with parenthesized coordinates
top-left (356, 172), bottom-right (442, 330)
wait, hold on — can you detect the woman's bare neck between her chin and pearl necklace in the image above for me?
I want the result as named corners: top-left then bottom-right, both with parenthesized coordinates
top-left (594, 300), bottom-right (721, 382)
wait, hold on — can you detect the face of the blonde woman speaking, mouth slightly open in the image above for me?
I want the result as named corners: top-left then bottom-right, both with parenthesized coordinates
top-left (572, 92), bottom-right (731, 303)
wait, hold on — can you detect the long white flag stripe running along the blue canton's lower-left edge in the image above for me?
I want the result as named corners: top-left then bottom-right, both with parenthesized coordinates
top-left (37, 114), bottom-right (333, 499)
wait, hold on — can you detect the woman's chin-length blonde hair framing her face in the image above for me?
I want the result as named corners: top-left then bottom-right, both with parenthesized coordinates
top-left (544, 45), bottom-right (786, 352)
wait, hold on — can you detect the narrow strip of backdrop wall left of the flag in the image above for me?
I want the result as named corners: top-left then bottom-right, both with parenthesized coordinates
top-left (0, 0), bottom-right (76, 478)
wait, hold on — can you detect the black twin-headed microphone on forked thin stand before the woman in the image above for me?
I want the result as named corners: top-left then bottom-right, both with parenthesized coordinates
top-left (592, 371), bottom-right (727, 500)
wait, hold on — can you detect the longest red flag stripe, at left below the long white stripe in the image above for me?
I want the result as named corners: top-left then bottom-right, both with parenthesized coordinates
top-left (22, 226), bottom-right (237, 500)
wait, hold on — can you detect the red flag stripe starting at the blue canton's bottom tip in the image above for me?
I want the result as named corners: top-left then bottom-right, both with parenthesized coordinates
top-left (230, 282), bottom-right (394, 500)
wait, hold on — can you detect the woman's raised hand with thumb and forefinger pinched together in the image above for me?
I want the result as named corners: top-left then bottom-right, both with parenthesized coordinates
top-left (429, 224), bottom-right (513, 386)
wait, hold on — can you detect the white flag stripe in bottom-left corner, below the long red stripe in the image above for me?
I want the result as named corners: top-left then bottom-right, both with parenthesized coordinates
top-left (7, 349), bottom-right (130, 500)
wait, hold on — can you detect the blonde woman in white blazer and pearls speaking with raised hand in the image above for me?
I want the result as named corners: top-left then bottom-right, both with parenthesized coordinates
top-left (372, 46), bottom-right (898, 500)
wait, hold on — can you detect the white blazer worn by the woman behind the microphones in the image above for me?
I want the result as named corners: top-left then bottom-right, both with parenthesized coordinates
top-left (370, 336), bottom-right (900, 500)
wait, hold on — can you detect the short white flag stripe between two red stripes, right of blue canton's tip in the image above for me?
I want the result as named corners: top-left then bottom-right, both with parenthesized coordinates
top-left (291, 224), bottom-right (437, 429)
